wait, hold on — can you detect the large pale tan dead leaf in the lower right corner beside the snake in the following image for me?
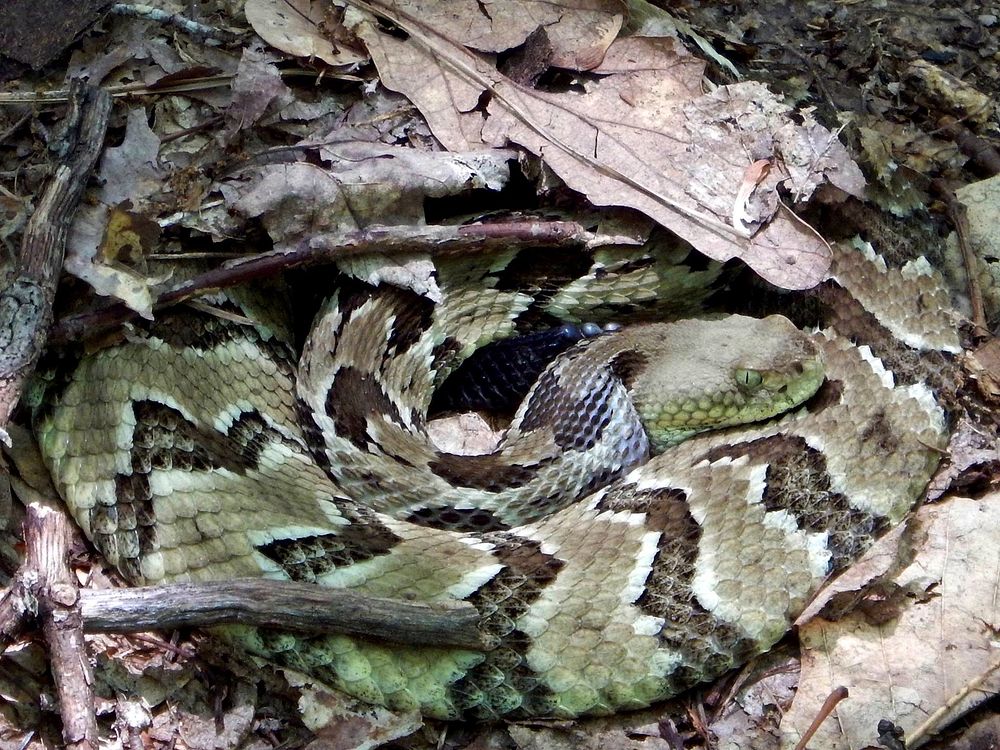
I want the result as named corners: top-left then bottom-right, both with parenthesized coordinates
top-left (781, 495), bottom-right (1000, 750)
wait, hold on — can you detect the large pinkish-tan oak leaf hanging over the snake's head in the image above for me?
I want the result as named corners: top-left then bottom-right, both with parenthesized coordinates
top-left (348, 0), bottom-right (863, 288)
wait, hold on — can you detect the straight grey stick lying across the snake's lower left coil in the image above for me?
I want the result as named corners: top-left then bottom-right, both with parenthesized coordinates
top-left (80, 578), bottom-right (483, 650)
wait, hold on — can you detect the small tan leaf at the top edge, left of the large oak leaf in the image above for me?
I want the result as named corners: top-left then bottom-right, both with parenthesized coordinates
top-left (243, 0), bottom-right (366, 65)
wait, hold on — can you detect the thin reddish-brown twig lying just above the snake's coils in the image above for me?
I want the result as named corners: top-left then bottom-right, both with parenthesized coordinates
top-left (49, 220), bottom-right (623, 344)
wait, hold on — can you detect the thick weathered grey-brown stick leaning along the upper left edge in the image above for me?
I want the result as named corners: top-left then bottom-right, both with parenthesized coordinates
top-left (0, 81), bottom-right (111, 432)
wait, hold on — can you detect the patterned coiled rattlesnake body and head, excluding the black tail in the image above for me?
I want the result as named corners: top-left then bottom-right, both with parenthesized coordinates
top-left (35, 241), bottom-right (958, 720)
